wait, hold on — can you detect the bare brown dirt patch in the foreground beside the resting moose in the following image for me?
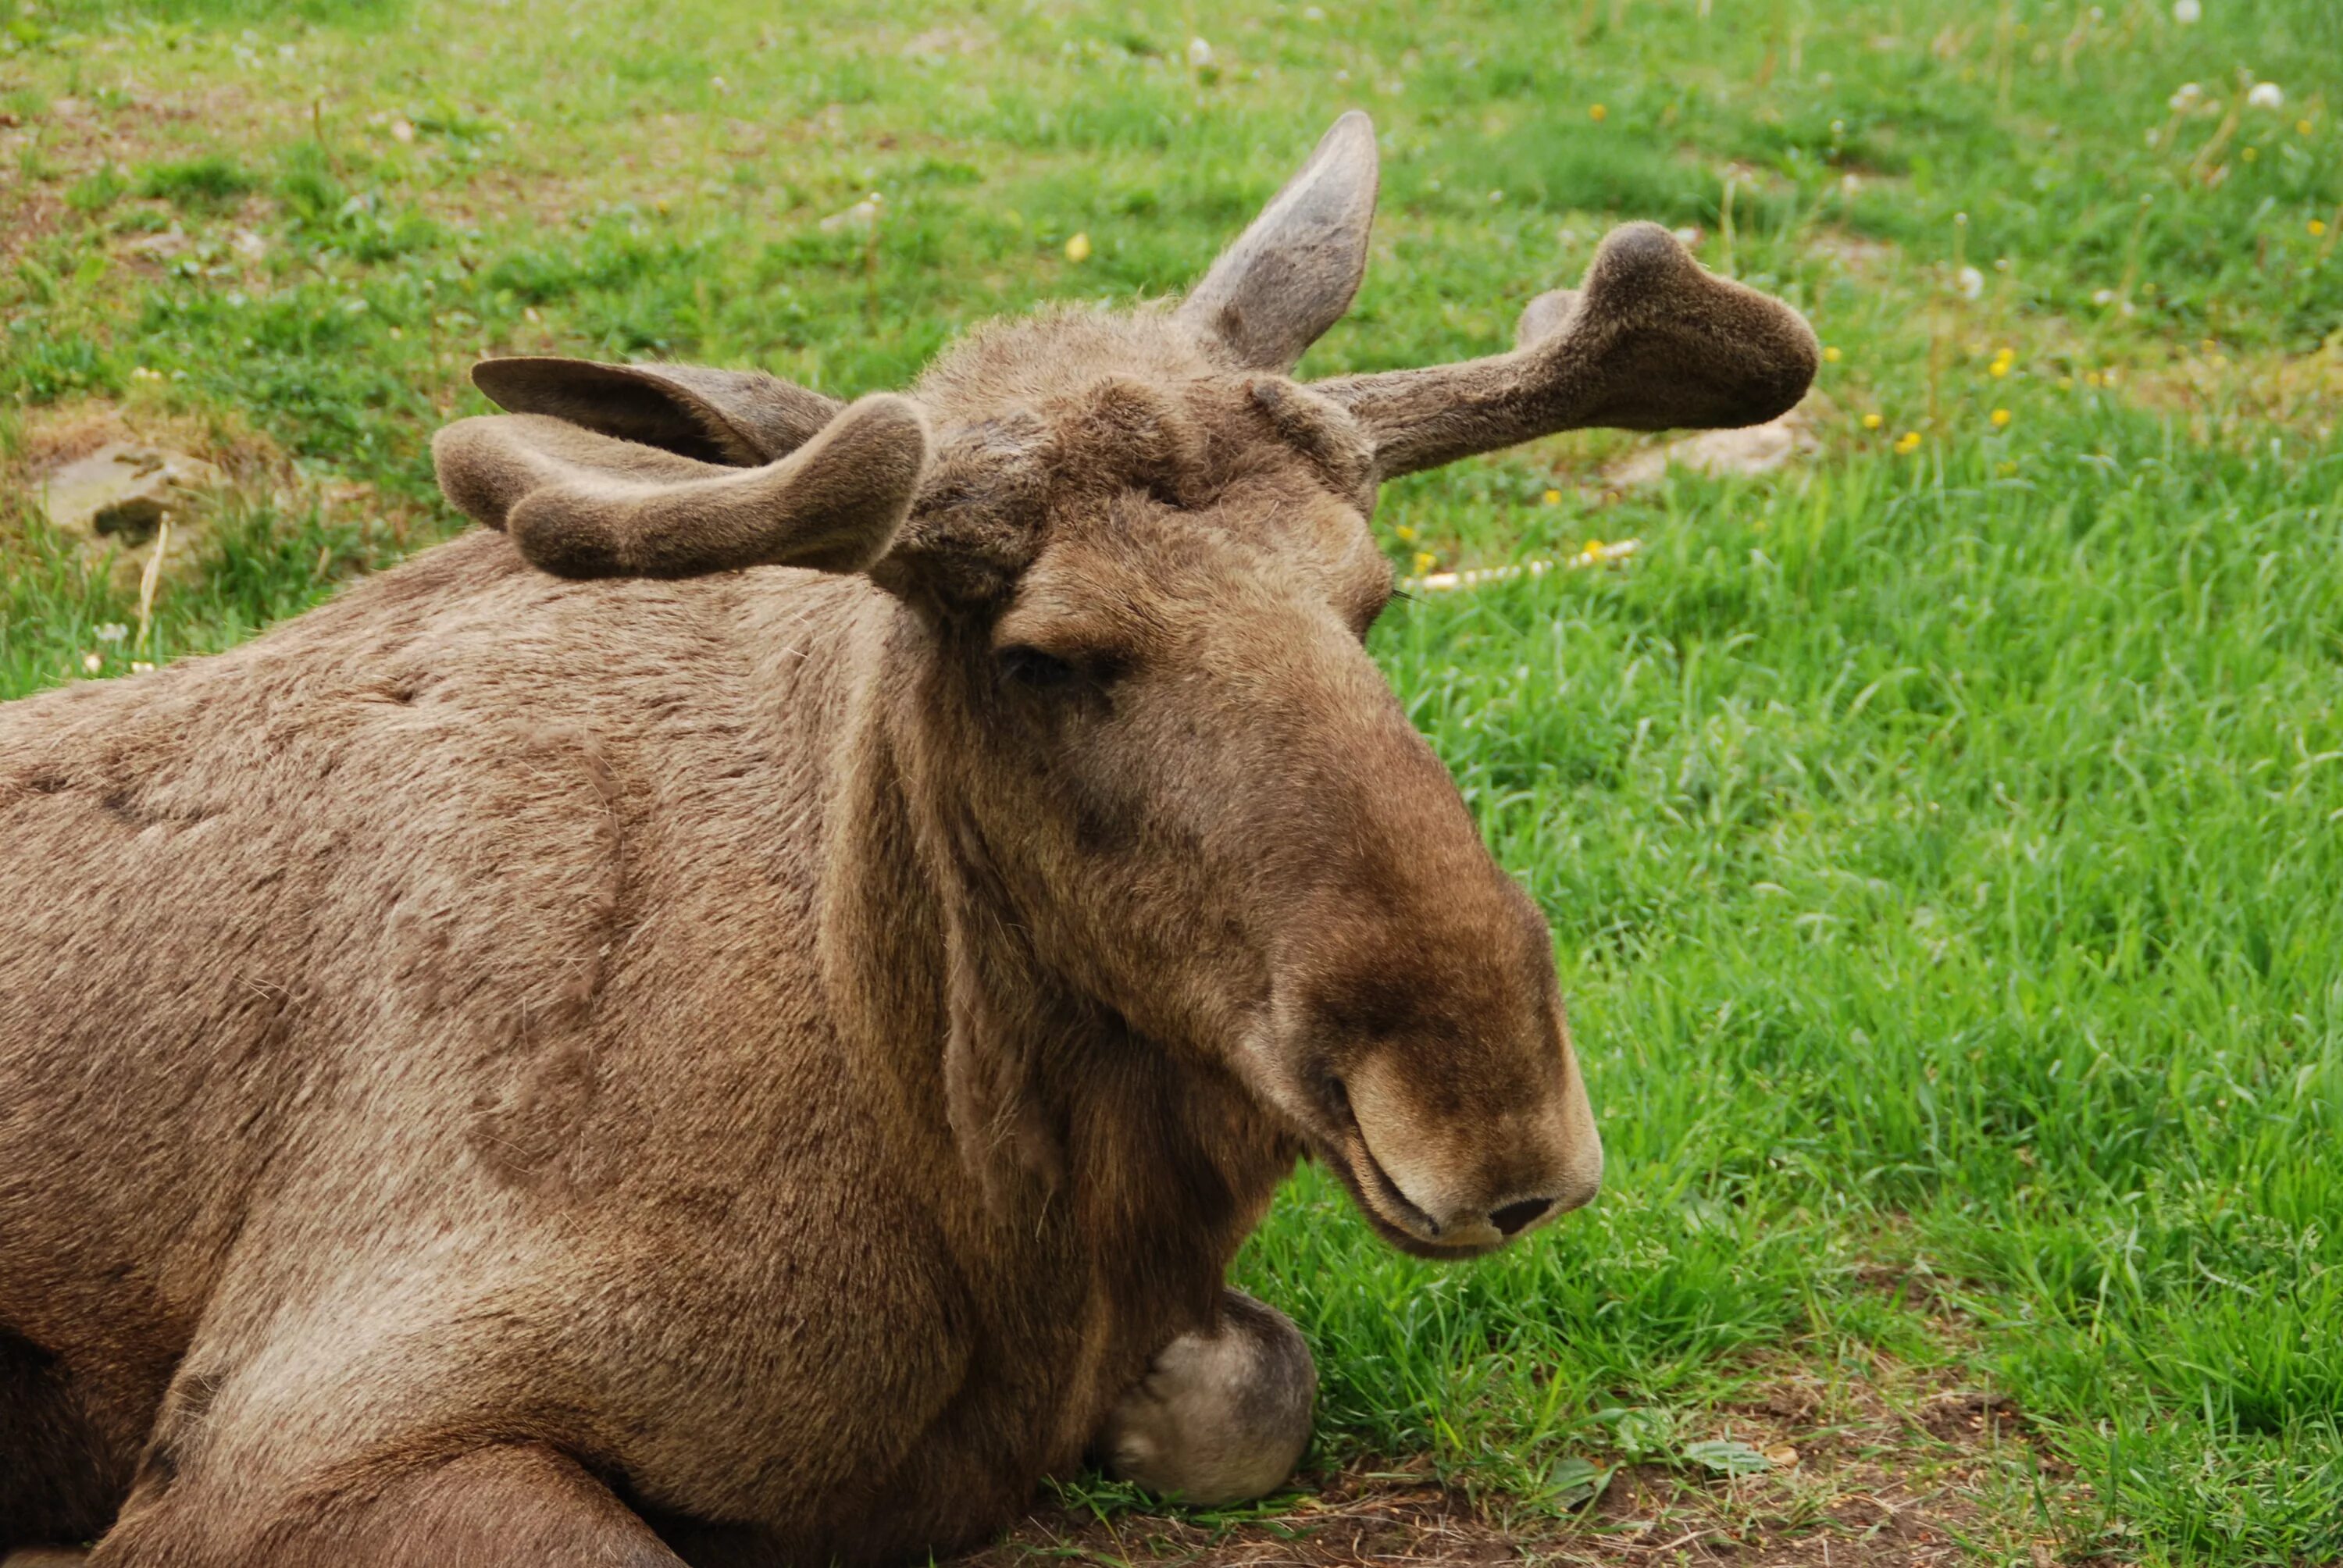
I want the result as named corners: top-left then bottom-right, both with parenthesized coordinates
top-left (951, 1364), bottom-right (2074, 1568)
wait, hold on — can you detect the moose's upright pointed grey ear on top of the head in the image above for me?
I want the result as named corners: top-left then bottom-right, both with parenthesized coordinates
top-left (1179, 110), bottom-right (1378, 375)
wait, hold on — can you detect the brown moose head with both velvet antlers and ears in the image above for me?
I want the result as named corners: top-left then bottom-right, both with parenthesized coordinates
top-left (436, 112), bottom-right (1816, 1256)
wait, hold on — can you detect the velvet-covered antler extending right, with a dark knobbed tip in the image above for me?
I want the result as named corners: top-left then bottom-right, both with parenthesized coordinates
top-left (1317, 223), bottom-right (1816, 478)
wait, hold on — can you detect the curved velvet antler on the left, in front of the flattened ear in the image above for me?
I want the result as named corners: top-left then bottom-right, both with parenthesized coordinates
top-left (431, 394), bottom-right (928, 576)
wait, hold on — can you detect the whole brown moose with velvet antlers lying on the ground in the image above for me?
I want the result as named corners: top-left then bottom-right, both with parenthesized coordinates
top-left (0, 115), bottom-right (1816, 1568)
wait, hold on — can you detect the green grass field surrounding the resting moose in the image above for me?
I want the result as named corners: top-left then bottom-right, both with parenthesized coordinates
top-left (0, 0), bottom-right (2343, 1563)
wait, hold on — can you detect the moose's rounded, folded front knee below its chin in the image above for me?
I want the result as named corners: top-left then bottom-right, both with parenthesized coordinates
top-left (1097, 1292), bottom-right (1317, 1507)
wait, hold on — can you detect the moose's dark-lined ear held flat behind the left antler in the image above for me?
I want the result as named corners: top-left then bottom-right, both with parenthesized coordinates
top-left (471, 356), bottom-right (843, 469)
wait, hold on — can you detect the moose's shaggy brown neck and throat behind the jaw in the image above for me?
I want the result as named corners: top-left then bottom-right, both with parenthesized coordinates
top-left (820, 611), bottom-right (1298, 1355)
